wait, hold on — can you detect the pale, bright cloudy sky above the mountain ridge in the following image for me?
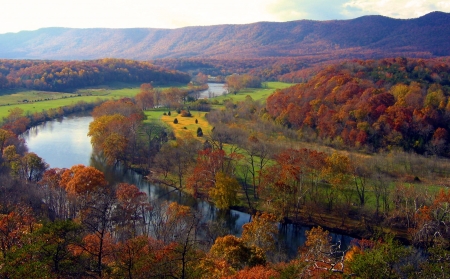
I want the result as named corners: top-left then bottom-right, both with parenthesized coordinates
top-left (0, 0), bottom-right (450, 34)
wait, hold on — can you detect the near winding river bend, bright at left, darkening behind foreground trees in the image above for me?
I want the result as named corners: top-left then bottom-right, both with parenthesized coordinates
top-left (22, 115), bottom-right (352, 256)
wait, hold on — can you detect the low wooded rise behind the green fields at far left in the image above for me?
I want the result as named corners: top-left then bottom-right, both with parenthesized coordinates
top-left (0, 58), bottom-right (190, 92)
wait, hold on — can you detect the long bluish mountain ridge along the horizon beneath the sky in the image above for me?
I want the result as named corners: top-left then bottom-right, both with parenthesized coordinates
top-left (0, 12), bottom-right (450, 60)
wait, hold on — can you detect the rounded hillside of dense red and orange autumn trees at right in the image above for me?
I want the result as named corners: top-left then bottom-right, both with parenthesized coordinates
top-left (266, 58), bottom-right (450, 156)
